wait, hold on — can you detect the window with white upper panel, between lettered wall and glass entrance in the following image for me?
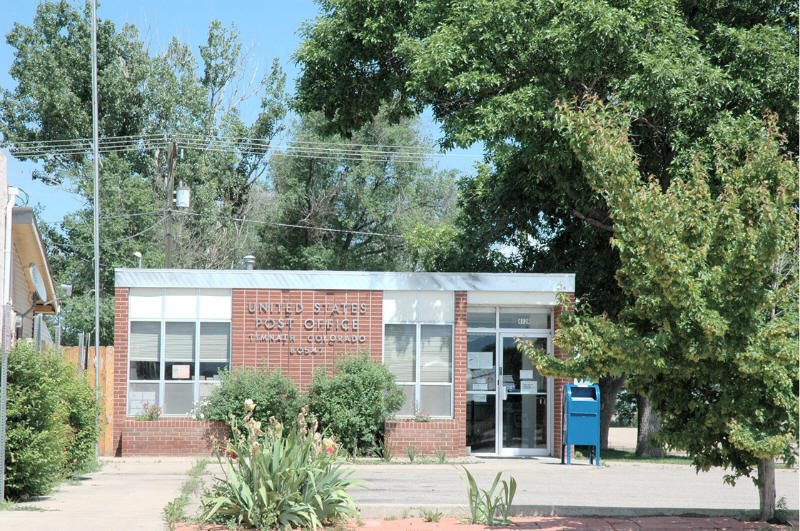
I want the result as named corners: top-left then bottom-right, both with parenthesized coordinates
top-left (383, 292), bottom-right (453, 417)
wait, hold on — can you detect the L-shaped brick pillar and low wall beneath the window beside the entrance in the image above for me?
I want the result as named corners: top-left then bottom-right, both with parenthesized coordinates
top-left (385, 291), bottom-right (467, 457)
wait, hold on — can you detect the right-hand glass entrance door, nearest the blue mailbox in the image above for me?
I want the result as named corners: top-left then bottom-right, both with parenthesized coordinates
top-left (497, 334), bottom-right (550, 455)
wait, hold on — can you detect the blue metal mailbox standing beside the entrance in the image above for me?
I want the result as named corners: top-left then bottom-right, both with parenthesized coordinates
top-left (561, 385), bottom-right (600, 466)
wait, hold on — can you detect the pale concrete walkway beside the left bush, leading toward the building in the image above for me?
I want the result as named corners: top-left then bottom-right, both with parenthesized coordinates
top-left (0, 457), bottom-right (197, 531)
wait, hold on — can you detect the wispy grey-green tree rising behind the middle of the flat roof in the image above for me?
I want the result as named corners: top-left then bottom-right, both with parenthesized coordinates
top-left (258, 113), bottom-right (457, 271)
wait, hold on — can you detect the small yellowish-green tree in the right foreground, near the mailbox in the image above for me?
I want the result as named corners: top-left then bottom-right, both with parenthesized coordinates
top-left (525, 98), bottom-right (800, 520)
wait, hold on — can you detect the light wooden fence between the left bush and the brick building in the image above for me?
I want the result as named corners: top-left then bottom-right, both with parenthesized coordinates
top-left (61, 347), bottom-right (114, 455)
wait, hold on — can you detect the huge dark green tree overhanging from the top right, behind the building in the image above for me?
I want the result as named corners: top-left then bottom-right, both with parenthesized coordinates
top-left (297, 0), bottom-right (798, 448)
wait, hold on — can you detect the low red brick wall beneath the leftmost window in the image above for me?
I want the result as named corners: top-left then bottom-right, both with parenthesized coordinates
top-left (120, 418), bottom-right (228, 456)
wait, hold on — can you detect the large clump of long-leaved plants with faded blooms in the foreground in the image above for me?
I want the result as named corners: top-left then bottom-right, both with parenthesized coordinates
top-left (202, 401), bottom-right (356, 530)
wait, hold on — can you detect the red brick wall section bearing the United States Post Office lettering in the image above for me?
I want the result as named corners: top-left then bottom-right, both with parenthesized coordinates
top-left (231, 289), bottom-right (383, 389)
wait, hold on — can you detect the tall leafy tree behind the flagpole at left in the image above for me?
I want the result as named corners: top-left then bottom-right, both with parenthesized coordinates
top-left (0, 1), bottom-right (287, 344)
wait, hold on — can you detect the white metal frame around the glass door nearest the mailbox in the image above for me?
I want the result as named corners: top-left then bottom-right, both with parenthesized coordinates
top-left (495, 328), bottom-right (553, 457)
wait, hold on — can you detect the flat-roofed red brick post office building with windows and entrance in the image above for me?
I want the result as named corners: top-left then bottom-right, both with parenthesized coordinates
top-left (113, 269), bottom-right (575, 456)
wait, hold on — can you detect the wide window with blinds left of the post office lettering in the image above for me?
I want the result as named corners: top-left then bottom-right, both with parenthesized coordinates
top-left (128, 321), bottom-right (230, 415)
